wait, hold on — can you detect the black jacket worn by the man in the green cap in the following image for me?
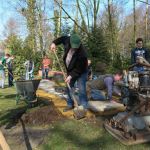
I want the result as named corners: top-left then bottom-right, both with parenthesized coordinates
top-left (53, 36), bottom-right (88, 79)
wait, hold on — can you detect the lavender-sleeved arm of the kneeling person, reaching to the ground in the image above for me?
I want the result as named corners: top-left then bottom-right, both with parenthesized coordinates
top-left (104, 77), bottom-right (113, 100)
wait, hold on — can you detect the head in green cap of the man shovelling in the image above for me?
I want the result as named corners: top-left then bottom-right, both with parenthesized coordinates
top-left (70, 34), bottom-right (81, 49)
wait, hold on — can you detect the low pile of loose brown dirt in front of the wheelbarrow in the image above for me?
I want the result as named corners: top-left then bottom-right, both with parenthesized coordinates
top-left (22, 105), bottom-right (64, 125)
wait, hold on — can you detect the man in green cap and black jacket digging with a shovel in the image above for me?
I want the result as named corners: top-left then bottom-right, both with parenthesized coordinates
top-left (50, 34), bottom-right (88, 112)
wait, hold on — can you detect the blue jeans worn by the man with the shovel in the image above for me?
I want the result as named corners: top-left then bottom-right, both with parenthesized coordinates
top-left (67, 72), bottom-right (88, 108)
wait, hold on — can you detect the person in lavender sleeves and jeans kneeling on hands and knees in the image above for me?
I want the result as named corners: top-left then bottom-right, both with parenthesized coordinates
top-left (86, 71), bottom-right (123, 102)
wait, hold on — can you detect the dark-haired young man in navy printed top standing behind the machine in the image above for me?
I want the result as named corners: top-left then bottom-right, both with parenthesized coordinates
top-left (131, 38), bottom-right (149, 72)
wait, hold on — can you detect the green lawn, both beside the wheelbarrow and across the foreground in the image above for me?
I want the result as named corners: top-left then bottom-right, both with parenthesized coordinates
top-left (0, 87), bottom-right (150, 150)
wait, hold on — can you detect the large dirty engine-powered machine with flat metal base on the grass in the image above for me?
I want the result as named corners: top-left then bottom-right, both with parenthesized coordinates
top-left (105, 67), bottom-right (150, 143)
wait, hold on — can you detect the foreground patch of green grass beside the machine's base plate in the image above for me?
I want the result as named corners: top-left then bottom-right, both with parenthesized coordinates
top-left (40, 120), bottom-right (150, 150)
